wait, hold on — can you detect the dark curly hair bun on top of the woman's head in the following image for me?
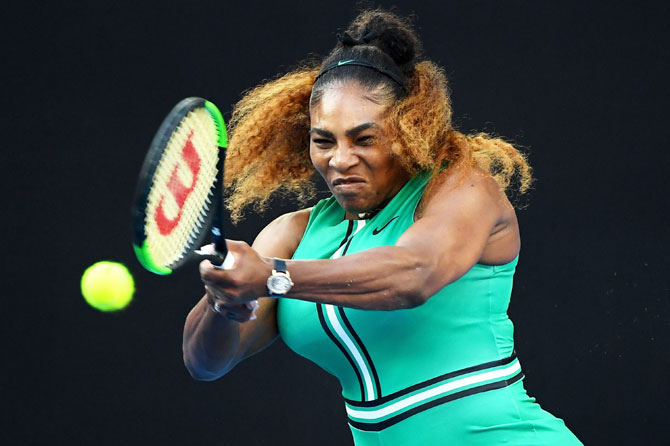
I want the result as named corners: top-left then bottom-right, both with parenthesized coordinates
top-left (347, 9), bottom-right (421, 68)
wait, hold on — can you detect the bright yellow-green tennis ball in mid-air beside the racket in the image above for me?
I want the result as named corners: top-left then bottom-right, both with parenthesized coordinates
top-left (81, 261), bottom-right (135, 311)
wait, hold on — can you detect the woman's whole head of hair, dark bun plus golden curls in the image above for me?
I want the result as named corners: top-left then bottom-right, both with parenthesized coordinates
top-left (225, 10), bottom-right (532, 221)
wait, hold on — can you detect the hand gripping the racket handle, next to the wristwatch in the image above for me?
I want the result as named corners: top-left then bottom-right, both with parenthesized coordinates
top-left (200, 240), bottom-right (272, 304)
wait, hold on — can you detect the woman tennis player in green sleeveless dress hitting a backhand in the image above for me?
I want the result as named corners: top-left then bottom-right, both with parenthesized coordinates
top-left (184, 10), bottom-right (581, 446)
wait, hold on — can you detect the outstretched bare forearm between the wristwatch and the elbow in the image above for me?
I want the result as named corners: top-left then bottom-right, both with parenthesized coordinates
top-left (287, 246), bottom-right (439, 310)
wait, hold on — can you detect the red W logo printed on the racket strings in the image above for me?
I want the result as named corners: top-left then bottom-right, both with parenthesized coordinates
top-left (154, 130), bottom-right (200, 235)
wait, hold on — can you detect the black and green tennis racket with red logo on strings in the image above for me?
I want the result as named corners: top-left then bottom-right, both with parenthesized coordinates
top-left (132, 97), bottom-right (234, 275)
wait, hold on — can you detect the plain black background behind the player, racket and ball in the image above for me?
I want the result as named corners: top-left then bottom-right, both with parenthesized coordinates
top-left (0, 0), bottom-right (670, 445)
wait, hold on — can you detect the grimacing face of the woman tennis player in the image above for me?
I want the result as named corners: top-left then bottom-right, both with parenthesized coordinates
top-left (309, 83), bottom-right (409, 217)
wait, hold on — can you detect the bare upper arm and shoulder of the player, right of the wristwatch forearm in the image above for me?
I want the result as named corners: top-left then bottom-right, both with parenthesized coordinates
top-left (396, 170), bottom-right (509, 295)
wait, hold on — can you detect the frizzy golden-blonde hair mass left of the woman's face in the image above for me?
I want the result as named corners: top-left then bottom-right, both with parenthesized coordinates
top-left (224, 68), bottom-right (318, 221)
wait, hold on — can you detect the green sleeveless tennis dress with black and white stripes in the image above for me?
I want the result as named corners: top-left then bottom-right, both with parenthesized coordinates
top-left (277, 174), bottom-right (581, 446)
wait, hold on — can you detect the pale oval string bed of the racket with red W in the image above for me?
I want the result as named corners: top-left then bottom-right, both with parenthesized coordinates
top-left (145, 108), bottom-right (219, 267)
